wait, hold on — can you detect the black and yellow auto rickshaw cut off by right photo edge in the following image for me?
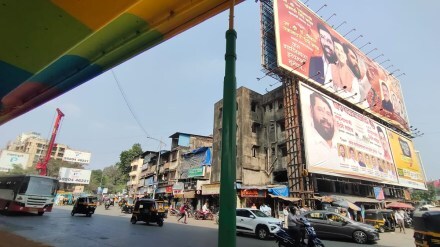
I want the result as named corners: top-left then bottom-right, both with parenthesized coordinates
top-left (413, 211), bottom-right (440, 247)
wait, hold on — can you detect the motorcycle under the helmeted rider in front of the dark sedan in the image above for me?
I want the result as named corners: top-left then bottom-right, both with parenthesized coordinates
top-left (274, 218), bottom-right (324, 247)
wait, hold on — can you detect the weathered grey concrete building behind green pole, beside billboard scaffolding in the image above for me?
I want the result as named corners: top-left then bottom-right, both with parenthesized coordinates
top-left (211, 87), bottom-right (288, 207)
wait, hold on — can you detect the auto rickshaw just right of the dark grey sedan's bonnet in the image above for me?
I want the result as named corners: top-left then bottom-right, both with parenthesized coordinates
top-left (364, 209), bottom-right (396, 232)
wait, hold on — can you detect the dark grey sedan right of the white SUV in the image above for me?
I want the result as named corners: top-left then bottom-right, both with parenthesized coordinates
top-left (301, 210), bottom-right (379, 244)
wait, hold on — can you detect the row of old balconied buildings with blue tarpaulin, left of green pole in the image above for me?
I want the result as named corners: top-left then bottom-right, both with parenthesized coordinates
top-left (141, 132), bottom-right (212, 207)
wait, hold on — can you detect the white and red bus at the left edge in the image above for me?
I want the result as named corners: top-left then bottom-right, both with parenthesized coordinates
top-left (0, 175), bottom-right (58, 216)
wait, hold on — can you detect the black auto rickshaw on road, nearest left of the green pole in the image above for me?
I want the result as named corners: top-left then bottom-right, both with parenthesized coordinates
top-left (130, 198), bottom-right (165, 226)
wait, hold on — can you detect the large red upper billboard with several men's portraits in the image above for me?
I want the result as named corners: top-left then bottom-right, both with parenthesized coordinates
top-left (274, 0), bottom-right (409, 131)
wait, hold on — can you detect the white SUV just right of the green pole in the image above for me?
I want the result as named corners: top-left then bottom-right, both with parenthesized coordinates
top-left (236, 208), bottom-right (281, 239)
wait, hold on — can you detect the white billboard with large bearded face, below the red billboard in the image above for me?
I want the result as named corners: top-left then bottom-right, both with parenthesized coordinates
top-left (300, 84), bottom-right (398, 184)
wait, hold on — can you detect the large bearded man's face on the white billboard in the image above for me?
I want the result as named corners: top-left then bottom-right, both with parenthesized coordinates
top-left (312, 98), bottom-right (335, 141)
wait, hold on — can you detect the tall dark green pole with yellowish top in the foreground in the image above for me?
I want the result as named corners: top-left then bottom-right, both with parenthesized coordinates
top-left (218, 0), bottom-right (237, 247)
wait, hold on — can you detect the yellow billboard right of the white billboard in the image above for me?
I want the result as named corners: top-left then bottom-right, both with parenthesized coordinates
top-left (387, 131), bottom-right (426, 189)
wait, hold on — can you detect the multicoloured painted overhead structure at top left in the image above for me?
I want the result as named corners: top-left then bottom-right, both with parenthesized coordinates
top-left (0, 0), bottom-right (240, 125)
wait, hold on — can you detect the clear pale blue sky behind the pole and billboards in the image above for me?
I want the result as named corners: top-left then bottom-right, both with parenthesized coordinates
top-left (0, 0), bottom-right (440, 179)
